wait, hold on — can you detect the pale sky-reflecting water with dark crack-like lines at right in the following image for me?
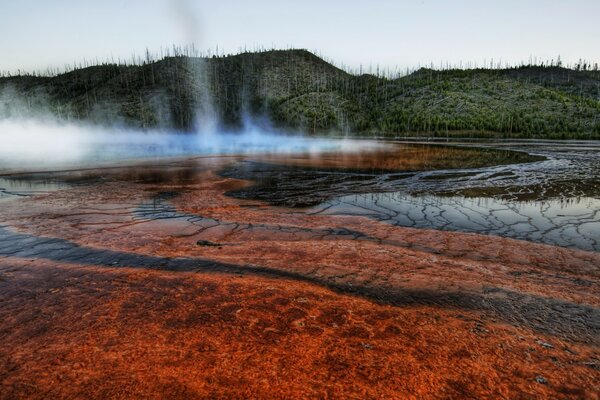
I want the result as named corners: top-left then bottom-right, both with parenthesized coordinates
top-left (311, 192), bottom-right (600, 251)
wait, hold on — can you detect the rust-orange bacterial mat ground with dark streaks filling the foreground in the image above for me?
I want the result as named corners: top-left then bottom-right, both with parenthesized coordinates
top-left (0, 155), bottom-right (600, 399)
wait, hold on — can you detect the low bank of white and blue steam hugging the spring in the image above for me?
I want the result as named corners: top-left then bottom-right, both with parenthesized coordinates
top-left (0, 119), bottom-right (372, 171)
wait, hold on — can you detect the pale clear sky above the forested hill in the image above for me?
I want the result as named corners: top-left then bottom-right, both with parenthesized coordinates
top-left (0, 0), bottom-right (600, 72)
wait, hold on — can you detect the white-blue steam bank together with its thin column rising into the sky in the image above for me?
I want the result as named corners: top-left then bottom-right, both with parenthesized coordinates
top-left (0, 0), bottom-right (366, 172)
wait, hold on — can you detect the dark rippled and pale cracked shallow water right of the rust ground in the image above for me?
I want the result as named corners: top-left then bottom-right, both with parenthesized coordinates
top-left (225, 142), bottom-right (600, 251)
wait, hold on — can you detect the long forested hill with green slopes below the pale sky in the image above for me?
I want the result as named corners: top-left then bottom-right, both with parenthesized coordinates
top-left (0, 50), bottom-right (600, 138)
